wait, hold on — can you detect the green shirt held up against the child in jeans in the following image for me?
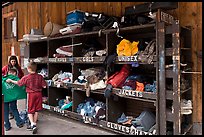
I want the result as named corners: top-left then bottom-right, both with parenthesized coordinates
top-left (2, 75), bottom-right (27, 102)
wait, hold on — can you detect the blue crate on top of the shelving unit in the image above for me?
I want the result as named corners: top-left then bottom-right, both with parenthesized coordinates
top-left (66, 10), bottom-right (84, 25)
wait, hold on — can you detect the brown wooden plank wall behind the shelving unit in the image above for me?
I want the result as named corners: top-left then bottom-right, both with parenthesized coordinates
top-left (2, 2), bottom-right (202, 125)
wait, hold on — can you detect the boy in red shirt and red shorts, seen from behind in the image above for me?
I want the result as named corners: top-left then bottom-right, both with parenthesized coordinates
top-left (7, 62), bottom-right (47, 134)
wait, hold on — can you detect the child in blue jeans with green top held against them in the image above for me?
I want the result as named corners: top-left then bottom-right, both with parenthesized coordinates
top-left (2, 68), bottom-right (26, 131)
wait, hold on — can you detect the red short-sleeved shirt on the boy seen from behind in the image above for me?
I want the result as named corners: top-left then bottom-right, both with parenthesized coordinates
top-left (17, 73), bottom-right (47, 93)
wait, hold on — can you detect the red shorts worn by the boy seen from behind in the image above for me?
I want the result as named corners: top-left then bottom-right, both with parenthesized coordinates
top-left (27, 92), bottom-right (43, 114)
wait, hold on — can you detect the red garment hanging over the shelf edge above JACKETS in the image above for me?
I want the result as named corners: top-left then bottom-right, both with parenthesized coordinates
top-left (107, 64), bottom-right (130, 88)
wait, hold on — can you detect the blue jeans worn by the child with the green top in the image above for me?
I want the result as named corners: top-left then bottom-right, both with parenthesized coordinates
top-left (4, 100), bottom-right (23, 129)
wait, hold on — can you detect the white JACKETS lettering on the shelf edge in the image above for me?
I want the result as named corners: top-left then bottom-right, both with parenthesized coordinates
top-left (118, 89), bottom-right (143, 97)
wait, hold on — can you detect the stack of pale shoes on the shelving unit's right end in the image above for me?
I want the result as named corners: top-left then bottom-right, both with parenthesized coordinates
top-left (181, 99), bottom-right (193, 115)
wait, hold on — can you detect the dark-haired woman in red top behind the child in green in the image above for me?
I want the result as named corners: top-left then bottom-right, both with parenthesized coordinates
top-left (2, 55), bottom-right (24, 78)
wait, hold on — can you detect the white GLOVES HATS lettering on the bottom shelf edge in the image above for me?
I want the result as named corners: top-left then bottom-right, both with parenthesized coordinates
top-left (106, 122), bottom-right (152, 135)
